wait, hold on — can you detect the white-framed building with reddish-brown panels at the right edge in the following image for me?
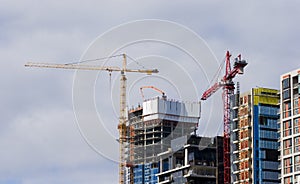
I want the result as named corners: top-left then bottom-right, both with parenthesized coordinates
top-left (280, 69), bottom-right (300, 184)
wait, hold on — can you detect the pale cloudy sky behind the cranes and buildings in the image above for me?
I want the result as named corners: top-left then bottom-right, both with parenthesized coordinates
top-left (0, 0), bottom-right (300, 184)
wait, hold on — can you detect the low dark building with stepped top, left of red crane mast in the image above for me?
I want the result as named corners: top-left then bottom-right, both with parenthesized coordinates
top-left (157, 135), bottom-right (224, 184)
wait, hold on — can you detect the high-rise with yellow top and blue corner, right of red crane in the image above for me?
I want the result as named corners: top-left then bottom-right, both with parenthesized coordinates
top-left (231, 88), bottom-right (279, 184)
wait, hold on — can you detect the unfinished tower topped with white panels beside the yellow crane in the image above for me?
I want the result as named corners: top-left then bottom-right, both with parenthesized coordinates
top-left (124, 97), bottom-right (201, 184)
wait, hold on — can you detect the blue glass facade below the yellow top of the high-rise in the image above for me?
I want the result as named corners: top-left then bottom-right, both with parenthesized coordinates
top-left (253, 103), bottom-right (279, 184)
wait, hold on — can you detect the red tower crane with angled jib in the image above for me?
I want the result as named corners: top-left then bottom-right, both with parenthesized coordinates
top-left (201, 51), bottom-right (248, 184)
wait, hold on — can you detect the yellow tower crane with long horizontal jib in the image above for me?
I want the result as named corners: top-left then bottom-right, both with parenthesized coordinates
top-left (25, 54), bottom-right (158, 184)
